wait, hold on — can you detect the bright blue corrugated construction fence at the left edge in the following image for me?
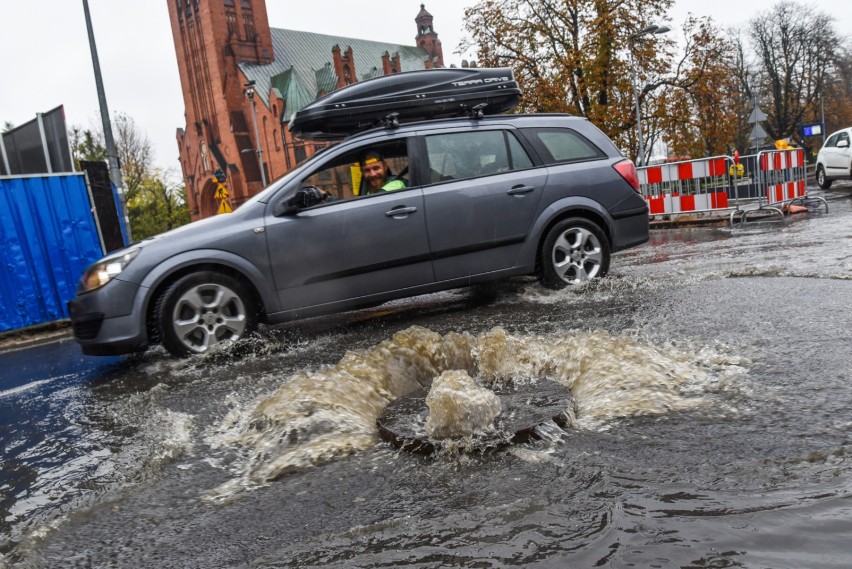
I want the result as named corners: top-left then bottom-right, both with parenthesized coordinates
top-left (0, 173), bottom-right (127, 332)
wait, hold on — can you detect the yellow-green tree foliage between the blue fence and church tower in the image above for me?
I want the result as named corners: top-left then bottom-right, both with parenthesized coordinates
top-left (70, 114), bottom-right (190, 241)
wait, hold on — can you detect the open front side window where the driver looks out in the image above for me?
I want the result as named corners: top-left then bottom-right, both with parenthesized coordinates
top-left (300, 139), bottom-right (411, 200)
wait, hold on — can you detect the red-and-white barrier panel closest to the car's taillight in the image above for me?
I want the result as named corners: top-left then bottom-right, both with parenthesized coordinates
top-left (636, 156), bottom-right (739, 223)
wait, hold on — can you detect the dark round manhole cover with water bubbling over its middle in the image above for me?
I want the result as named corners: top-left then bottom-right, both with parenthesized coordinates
top-left (376, 380), bottom-right (574, 454)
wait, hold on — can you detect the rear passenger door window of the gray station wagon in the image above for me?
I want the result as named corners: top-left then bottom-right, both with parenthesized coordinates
top-left (426, 130), bottom-right (532, 183)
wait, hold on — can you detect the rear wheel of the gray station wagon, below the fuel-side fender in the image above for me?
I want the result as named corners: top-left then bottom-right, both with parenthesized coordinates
top-left (536, 217), bottom-right (610, 290)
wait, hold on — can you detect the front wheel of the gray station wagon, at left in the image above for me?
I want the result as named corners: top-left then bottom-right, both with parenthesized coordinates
top-left (156, 271), bottom-right (257, 357)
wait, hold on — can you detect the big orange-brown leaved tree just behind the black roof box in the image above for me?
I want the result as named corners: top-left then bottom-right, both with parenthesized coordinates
top-left (465, 0), bottom-right (672, 133)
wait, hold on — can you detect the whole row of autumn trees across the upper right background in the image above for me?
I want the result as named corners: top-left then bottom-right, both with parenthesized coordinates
top-left (461, 0), bottom-right (852, 161)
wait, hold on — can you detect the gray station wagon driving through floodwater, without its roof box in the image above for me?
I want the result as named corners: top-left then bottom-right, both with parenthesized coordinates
top-left (69, 111), bottom-right (648, 355)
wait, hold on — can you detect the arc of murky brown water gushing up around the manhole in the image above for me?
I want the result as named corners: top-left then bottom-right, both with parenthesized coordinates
top-left (210, 326), bottom-right (744, 498)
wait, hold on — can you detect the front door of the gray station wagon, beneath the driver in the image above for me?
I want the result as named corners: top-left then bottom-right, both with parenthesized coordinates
top-left (265, 139), bottom-right (434, 311)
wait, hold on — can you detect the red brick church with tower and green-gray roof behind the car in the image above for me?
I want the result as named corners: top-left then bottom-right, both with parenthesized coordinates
top-left (169, 0), bottom-right (444, 220)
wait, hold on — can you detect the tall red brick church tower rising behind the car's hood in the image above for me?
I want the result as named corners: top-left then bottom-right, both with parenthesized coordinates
top-left (168, 0), bottom-right (274, 219)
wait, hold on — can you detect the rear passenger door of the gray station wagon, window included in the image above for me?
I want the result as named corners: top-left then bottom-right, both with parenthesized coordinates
top-left (421, 128), bottom-right (547, 281)
